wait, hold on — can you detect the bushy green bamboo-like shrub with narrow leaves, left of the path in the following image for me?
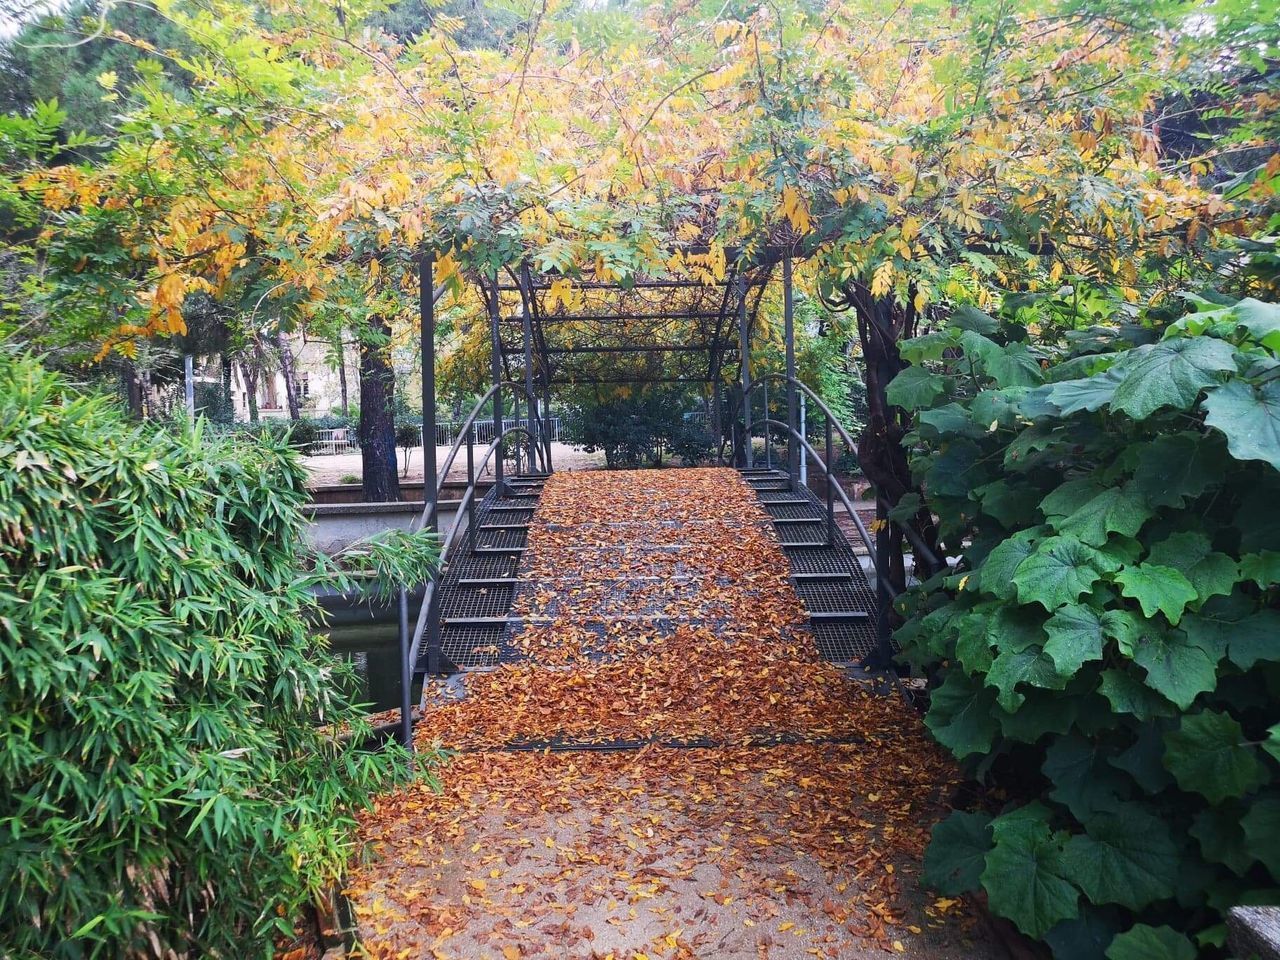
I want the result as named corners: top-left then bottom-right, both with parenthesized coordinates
top-left (0, 352), bottom-right (435, 959)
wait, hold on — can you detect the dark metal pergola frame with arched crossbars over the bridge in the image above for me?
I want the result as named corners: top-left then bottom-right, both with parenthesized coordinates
top-left (419, 246), bottom-right (800, 489)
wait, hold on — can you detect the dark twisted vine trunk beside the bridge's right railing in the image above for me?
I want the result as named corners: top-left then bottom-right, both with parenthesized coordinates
top-left (846, 284), bottom-right (938, 591)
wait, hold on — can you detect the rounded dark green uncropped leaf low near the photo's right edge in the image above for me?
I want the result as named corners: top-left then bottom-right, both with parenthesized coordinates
top-left (1165, 710), bottom-right (1267, 804)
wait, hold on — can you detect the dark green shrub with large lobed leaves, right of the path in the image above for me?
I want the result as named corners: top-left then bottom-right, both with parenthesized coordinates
top-left (890, 300), bottom-right (1280, 960)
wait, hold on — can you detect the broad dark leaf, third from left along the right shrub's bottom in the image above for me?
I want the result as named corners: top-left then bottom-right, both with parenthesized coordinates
top-left (1064, 805), bottom-right (1179, 910)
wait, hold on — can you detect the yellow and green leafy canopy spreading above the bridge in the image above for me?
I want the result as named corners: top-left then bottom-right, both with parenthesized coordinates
top-left (0, 0), bottom-right (1280, 368)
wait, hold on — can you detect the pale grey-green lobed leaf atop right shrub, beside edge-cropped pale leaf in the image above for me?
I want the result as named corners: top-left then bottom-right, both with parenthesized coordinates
top-left (1111, 338), bottom-right (1235, 420)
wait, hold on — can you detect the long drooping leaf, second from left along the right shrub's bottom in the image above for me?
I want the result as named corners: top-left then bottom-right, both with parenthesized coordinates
top-left (982, 805), bottom-right (1079, 938)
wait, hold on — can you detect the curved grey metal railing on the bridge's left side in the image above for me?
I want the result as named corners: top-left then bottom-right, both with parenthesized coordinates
top-left (398, 380), bottom-right (552, 750)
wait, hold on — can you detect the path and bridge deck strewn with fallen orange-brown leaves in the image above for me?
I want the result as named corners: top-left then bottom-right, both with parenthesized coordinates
top-left (351, 470), bottom-right (987, 960)
